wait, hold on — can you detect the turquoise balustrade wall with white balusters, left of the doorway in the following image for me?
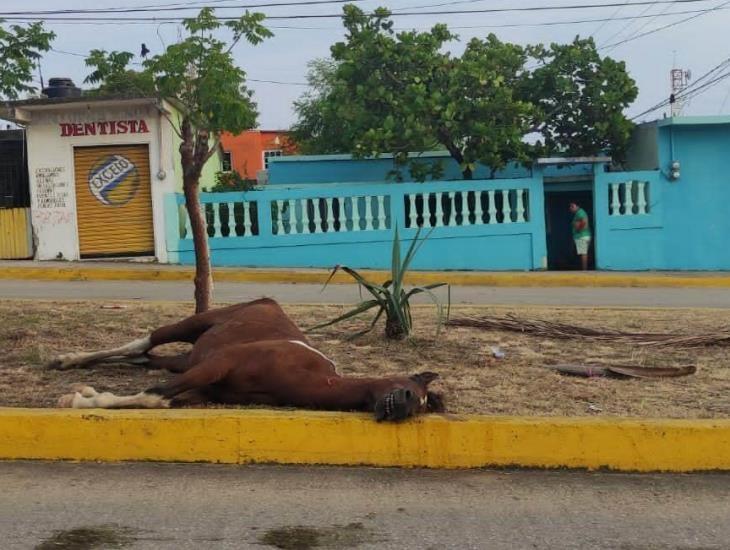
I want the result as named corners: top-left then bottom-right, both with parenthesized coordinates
top-left (166, 176), bottom-right (547, 270)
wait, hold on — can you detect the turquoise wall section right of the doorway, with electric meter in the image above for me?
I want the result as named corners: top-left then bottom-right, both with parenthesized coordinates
top-left (594, 117), bottom-right (730, 270)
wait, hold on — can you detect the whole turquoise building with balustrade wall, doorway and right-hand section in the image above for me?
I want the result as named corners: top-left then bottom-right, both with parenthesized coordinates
top-left (166, 117), bottom-right (730, 270)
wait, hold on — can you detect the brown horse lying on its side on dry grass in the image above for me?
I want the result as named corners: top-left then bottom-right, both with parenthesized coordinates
top-left (49, 299), bottom-right (443, 421)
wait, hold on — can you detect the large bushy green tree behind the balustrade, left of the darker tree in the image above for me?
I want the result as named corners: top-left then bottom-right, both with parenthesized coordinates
top-left (296, 5), bottom-right (534, 179)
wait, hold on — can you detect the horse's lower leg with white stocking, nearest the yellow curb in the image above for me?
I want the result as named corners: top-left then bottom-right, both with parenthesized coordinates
top-left (58, 361), bottom-right (229, 409)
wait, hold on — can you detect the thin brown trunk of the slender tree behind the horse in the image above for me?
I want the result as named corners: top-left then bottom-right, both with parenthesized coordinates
top-left (183, 178), bottom-right (213, 313)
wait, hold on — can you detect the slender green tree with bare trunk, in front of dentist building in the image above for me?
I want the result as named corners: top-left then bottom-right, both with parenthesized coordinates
top-left (82, 8), bottom-right (272, 313)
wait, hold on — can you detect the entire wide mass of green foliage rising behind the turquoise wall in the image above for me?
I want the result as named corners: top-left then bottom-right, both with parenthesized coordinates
top-left (294, 5), bottom-right (637, 180)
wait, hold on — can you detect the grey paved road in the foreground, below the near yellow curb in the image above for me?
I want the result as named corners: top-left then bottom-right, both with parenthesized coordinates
top-left (0, 462), bottom-right (730, 550)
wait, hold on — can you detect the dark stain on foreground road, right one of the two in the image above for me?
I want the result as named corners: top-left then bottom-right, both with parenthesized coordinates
top-left (259, 523), bottom-right (385, 550)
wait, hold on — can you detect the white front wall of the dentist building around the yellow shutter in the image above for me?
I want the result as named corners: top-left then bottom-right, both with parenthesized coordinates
top-left (27, 102), bottom-right (180, 262)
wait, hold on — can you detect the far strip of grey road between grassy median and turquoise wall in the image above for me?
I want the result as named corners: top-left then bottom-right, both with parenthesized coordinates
top-left (0, 280), bottom-right (730, 308)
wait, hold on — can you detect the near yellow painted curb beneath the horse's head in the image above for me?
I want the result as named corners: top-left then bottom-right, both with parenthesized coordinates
top-left (0, 408), bottom-right (730, 472)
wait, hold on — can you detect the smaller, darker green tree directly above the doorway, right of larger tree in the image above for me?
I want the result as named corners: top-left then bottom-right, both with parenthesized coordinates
top-left (520, 37), bottom-right (639, 161)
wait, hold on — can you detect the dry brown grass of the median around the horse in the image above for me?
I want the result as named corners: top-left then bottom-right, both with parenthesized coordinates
top-left (0, 301), bottom-right (730, 418)
